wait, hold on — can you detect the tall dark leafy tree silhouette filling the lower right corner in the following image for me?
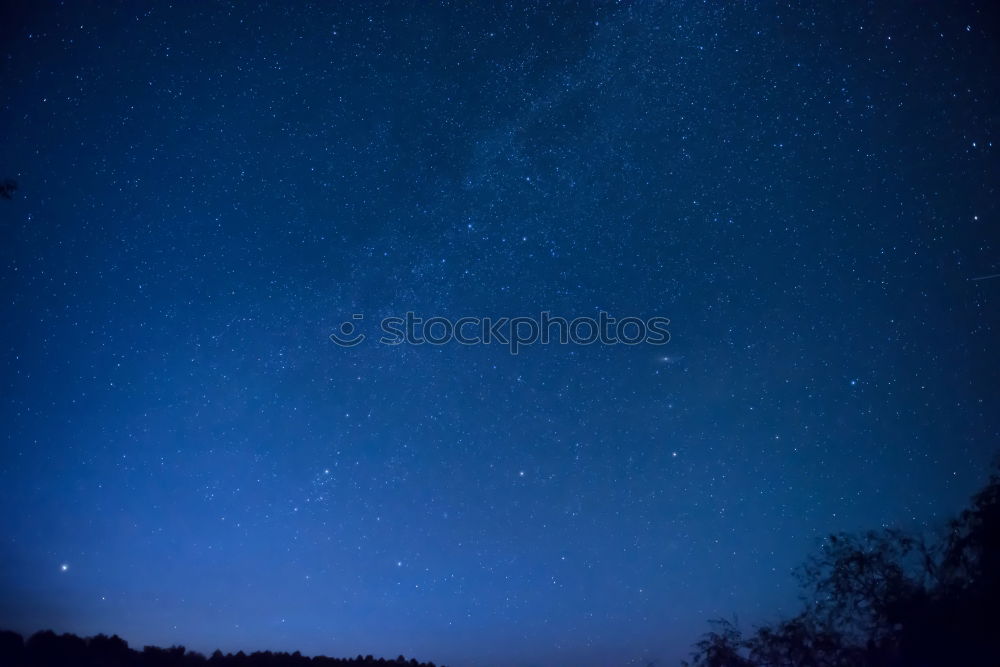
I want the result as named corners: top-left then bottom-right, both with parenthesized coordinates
top-left (683, 461), bottom-right (1000, 667)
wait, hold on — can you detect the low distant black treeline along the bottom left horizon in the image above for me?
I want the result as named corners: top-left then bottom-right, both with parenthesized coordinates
top-left (0, 630), bottom-right (443, 667)
